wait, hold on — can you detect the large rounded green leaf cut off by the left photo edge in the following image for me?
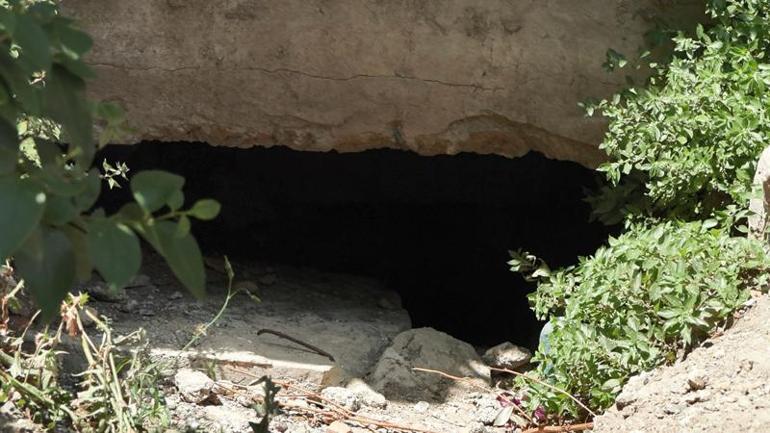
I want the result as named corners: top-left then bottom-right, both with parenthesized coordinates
top-left (0, 175), bottom-right (46, 259)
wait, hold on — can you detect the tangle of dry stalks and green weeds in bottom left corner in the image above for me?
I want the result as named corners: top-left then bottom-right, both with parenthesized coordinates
top-left (0, 283), bottom-right (169, 433)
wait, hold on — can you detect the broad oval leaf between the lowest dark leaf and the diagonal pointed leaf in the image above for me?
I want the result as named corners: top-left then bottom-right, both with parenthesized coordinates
top-left (86, 218), bottom-right (142, 288)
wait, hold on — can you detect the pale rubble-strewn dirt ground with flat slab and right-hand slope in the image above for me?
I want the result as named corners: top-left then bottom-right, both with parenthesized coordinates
top-left (0, 253), bottom-right (770, 433)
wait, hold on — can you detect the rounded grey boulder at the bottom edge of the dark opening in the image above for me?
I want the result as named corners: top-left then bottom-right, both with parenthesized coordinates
top-left (369, 328), bottom-right (490, 401)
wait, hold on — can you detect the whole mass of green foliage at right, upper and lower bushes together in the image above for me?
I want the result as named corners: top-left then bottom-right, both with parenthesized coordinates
top-left (510, 0), bottom-right (770, 421)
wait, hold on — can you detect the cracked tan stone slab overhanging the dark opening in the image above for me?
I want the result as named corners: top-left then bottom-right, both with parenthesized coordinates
top-left (61, 0), bottom-right (702, 166)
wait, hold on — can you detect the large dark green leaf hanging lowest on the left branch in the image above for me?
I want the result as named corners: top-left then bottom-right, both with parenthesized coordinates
top-left (14, 227), bottom-right (75, 320)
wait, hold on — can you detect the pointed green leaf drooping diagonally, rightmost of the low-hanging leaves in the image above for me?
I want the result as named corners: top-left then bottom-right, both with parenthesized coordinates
top-left (138, 221), bottom-right (206, 298)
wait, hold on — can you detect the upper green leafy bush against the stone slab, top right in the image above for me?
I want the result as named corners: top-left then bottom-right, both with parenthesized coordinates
top-left (588, 0), bottom-right (770, 224)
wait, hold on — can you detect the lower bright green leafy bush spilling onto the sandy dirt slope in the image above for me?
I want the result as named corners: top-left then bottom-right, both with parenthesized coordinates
top-left (511, 222), bottom-right (770, 418)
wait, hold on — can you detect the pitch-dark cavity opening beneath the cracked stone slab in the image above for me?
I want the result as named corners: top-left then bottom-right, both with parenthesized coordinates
top-left (98, 142), bottom-right (610, 348)
